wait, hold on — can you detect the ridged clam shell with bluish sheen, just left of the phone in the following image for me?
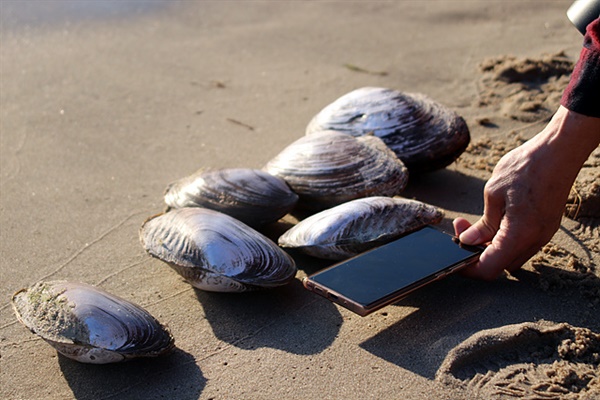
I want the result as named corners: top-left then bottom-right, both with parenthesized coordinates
top-left (140, 208), bottom-right (296, 292)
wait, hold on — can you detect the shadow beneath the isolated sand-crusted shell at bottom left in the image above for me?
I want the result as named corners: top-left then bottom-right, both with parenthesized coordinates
top-left (58, 349), bottom-right (206, 400)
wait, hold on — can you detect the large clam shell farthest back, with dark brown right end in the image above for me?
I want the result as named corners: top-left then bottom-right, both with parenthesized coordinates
top-left (306, 87), bottom-right (470, 172)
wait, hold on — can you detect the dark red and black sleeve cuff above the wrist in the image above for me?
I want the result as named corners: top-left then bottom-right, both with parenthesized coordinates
top-left (560, 18), bottom-right (600, 118)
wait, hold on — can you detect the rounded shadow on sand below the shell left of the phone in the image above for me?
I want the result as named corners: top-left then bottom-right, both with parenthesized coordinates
top-left (195, 279), bottom-right (342, 355)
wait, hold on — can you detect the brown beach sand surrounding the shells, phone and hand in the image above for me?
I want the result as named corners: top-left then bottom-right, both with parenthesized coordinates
top-left (0, 0), bottom-right (600, 399)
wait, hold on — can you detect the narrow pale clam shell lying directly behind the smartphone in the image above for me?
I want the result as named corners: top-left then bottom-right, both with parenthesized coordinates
top-left (279, 196), bottom-right (444, 260)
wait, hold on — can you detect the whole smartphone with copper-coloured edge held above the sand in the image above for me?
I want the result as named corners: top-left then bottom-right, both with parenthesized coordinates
top-left (303, 226), bottom-right (483, 316)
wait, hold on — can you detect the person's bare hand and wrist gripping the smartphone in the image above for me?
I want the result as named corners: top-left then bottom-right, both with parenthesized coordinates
top-left (453, 106), bottom-right (600, 280)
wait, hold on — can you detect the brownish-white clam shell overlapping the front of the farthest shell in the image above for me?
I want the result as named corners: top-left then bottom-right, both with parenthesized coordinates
top-left (264, 131), bottom-right (408, 211)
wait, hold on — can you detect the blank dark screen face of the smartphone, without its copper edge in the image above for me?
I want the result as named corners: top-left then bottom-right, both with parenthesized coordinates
top-left (310, 226), bottom-right (481, 307)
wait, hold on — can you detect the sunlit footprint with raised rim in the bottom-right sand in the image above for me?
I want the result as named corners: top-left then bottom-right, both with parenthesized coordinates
top-left (436, 321), bottom-right (600, 400)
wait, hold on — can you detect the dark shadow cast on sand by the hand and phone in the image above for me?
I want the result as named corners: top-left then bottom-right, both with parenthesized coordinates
top-left (360, 271), bottom-right (600, 380)
